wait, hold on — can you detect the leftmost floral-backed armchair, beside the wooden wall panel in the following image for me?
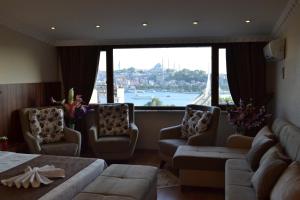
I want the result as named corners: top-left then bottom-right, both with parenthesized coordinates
top-left (19, 107), bottom-right (81, 156)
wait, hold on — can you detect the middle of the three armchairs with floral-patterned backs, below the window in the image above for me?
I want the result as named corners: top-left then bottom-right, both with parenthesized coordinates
top-left (86, 103), bottom-right (138, 160)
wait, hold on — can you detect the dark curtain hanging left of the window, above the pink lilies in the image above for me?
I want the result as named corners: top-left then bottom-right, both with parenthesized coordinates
top-left (58, 46), bottom-right (100, 103)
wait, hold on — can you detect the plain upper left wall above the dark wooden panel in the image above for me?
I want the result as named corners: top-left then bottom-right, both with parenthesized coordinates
top-left (0, 25), bottom-right (59, 84)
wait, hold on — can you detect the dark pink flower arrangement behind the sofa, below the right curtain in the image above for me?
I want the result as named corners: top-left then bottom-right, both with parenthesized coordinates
top-left (227, 100), bottom-right (271, 135)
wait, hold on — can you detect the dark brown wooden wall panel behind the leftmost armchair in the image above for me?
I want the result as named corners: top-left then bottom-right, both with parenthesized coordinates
top-left (0, 82), bottom-right (61, 142)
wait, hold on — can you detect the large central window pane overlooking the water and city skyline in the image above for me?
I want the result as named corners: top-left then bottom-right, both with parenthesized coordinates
top-left (113, 47), bottom-right (211, 106)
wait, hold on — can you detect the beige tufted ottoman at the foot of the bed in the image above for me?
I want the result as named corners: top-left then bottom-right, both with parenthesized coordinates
top-left (74, 164), bottom-right (158, 200)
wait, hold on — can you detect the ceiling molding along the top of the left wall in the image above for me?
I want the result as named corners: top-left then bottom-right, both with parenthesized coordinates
top-left (0, 15), bottom-right (55, 45)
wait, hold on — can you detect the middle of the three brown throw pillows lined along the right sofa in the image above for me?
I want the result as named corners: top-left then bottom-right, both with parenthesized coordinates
top-left (251, 159), bottom-right (287, 200)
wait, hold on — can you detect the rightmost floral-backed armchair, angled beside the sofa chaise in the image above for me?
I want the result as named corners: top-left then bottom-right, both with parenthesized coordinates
top-left (159, 104), bottom-right (220, 167)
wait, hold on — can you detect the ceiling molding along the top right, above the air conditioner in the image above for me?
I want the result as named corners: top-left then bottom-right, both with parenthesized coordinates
top-left (272, 0), bottom-right (299, 37)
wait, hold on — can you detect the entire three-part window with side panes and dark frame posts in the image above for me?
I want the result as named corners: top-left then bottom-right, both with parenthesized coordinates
top-left (90, 46), bottom-right (232, 108)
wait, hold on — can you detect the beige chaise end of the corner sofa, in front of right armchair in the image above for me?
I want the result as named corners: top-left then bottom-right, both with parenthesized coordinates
top-left (173, 145), bottom-right (248, 188)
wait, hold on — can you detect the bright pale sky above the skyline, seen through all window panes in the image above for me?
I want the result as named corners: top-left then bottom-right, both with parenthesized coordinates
top-left (99, 47), bottom-right (226, 74)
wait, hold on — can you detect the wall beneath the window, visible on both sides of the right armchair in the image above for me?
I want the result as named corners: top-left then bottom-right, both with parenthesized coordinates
top-left (135, 111), bottom-right (234, 149)
